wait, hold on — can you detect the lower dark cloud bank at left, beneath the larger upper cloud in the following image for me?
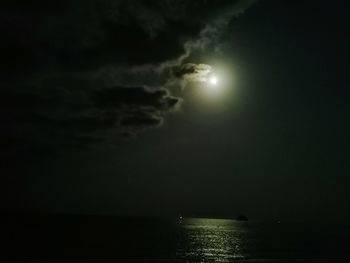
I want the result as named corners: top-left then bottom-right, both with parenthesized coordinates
top-left (0, 86), bottom-right (181, 157)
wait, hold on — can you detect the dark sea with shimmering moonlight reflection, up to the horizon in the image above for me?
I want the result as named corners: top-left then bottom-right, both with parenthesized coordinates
top-left (1, 216), bottom-right (350, 262)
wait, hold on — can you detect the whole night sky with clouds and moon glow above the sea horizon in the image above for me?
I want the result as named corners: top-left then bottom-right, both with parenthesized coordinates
top-left (0, 0), bottom-right (350, 221)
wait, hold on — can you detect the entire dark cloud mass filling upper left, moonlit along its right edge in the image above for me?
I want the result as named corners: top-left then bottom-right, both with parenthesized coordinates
top-left (0, 0), bottom-right (253, 156)
